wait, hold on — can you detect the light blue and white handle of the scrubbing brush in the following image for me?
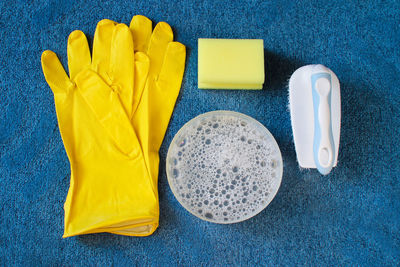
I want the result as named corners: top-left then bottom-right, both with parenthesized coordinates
top-left (311, 72), bottom-right (335, 175)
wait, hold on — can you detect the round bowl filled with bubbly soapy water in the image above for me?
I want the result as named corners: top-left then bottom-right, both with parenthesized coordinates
top-left (167, 111), bottom-right (282, 223)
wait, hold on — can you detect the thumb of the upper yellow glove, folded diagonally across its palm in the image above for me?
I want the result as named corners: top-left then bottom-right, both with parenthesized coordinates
top-left (76, 69), bottom-right (142, 157)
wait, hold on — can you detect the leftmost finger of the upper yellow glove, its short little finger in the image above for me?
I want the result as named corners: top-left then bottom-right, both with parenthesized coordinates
top-left (41, 50), bottom-right (73, 94)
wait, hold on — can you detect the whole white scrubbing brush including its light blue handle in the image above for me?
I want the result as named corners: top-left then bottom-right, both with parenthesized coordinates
top-left (289, 64), bottom-right (341, 174)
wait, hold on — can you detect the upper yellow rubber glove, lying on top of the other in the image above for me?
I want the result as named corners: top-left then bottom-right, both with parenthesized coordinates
top-left (42, 21), bottom-right (159, 237)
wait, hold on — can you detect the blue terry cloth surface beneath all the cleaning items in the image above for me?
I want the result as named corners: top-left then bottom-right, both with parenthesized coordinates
top-left (0, 0), bottom-right (400, 266)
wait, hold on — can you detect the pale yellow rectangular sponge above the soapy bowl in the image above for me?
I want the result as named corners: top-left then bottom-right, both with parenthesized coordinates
top-left (198, 38), bottom-right (265, 89)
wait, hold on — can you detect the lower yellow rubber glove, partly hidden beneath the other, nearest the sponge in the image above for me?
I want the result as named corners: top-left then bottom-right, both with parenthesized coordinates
top-left (130, 15), bottom-right (186, 197)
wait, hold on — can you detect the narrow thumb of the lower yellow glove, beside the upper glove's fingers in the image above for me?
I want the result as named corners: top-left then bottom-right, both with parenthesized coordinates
top-left (132, 52), bottom-right (150, 115)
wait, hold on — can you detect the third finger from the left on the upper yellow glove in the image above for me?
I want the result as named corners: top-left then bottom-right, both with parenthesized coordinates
top-left (92, 19), bottom-right (116, 81)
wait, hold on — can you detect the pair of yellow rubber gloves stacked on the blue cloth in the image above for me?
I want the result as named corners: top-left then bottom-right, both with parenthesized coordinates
top-left (42, 16), bottom-right (186, 237)
